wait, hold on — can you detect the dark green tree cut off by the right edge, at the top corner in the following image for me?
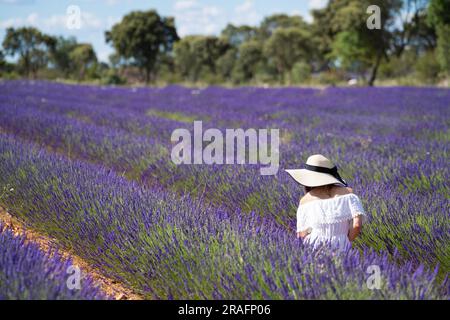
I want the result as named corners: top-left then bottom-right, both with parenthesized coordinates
top-left (428, 0), bottom-right (450, 76)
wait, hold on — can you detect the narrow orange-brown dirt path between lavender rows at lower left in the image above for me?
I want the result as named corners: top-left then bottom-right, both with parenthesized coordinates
top-left (0, 207), bottom-right (143, 300)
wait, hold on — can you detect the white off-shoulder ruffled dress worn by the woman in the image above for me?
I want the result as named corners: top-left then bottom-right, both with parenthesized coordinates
top-left (297, 193), bottom-right (365, 250)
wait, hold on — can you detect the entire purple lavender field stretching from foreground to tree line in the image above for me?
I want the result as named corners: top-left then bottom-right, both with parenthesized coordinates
top-left (0, 81), bottom-right (450, 299)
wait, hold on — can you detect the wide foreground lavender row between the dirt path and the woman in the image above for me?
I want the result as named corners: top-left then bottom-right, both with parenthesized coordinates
top-left (0, 135), bottom-right (448, 299)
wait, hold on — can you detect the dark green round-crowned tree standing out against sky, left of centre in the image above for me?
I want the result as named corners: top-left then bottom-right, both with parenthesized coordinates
top-left (105, 10), bottom-right (179, 83)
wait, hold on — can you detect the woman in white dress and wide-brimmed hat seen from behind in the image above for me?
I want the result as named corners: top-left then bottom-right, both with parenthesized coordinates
top-left (286, 154), bottom-right (365, 249)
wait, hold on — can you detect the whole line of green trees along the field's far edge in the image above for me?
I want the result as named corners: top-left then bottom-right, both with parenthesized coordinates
top-left (0, 0), bottom-right (450, 85)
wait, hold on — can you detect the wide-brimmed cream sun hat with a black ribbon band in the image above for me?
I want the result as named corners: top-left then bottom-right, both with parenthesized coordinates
top-left (286, 154), bottom-right (347, 187)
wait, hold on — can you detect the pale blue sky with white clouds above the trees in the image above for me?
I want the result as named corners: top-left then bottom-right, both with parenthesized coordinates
top-left (0, 0), bottom-right (327, 62)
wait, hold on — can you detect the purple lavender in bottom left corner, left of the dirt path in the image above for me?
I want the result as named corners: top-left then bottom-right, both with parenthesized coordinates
top-left (0, 224), bottom-right (107, 300)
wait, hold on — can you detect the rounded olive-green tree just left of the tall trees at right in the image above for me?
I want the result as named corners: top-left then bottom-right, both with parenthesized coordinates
top-left (264, 28), bottom-right (310, 83)
